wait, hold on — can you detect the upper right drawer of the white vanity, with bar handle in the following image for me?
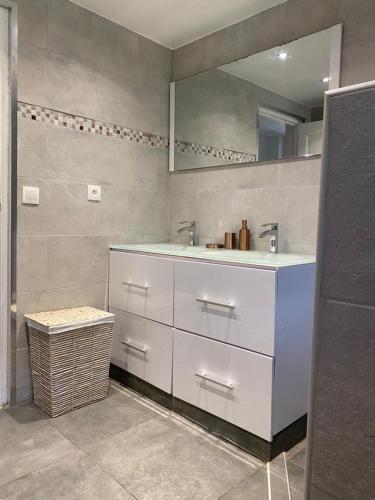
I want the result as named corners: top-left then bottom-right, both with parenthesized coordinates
top-left (174, 261), bottom-right (276, 356)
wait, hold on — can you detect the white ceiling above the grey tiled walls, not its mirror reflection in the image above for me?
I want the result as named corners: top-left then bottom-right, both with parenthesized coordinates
top-left (72, 0), bottom-right (286, 49)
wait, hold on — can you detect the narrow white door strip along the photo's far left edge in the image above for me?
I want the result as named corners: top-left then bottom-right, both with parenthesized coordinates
top-left (0, 7), bottom-right (10, 407)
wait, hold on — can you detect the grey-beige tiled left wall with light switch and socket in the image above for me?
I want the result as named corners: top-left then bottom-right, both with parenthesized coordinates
top-left (15, 0), bottom-right (172, 401)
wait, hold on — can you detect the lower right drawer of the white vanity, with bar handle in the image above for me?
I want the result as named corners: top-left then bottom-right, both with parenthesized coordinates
top-left (173, 330), bottom-right (273, 441)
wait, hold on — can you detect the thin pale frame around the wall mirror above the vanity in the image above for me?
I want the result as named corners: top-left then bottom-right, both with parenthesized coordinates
top-left (169, 24), bottom-right (342, 172)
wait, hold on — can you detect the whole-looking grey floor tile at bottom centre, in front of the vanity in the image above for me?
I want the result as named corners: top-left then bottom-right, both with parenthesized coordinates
top-left (89, 416), bottom-right (255, 500)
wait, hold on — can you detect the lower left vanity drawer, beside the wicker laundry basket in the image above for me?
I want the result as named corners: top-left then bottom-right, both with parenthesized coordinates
top-left (110, 308), bottom-right (172, 394)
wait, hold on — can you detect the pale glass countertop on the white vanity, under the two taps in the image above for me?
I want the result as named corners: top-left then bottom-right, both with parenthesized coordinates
top-left (110, 243), bottom-right (315, 269)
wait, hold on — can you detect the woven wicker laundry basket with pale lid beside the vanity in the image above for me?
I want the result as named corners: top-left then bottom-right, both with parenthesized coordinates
top-left (25, 307), bottom-right (114, 417)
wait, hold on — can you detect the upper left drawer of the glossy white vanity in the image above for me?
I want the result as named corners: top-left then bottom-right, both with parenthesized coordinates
top-left (109, 251), bottom-right (173, 325)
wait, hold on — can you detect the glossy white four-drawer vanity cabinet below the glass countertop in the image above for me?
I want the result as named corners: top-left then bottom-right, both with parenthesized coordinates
top-left (109, 250), bottom-right (315, 448)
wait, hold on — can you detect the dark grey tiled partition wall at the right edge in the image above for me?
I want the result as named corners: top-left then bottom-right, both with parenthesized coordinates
top-left (308, 86), bottom-right (375, 500)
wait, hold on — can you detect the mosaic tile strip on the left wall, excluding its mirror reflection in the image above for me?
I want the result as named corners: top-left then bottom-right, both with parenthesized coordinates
top-left (17, 101), bottom-right (169, 149)
